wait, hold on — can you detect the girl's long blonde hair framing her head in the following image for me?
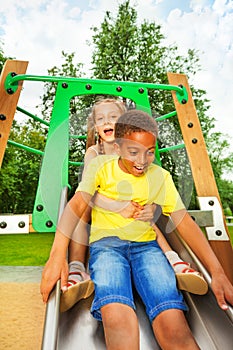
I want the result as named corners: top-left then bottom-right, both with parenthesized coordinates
top-left (86, 98), bottom-right (126, 154)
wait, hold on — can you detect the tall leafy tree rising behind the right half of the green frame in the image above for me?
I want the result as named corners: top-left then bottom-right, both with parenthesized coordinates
top-left (88, 0), bottom-right (220, 207)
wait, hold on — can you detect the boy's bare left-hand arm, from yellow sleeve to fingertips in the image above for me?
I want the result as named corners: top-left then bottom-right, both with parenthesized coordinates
top-left (40, 192), bottom-right (92, 302)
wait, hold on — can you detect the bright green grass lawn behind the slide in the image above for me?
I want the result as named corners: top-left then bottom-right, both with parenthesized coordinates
top-left (0, 226), bottom-right (233, 266)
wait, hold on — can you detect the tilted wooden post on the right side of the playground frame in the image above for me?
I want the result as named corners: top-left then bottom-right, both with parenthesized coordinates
top-left (168, 73), bottom-right (233, 283)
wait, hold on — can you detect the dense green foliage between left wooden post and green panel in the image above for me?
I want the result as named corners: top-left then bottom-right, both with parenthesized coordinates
top-left (0, 121), bottom-right (45, 214)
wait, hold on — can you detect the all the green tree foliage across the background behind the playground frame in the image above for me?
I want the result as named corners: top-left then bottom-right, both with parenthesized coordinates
top-left (0, 0), bottom-right (233, 213)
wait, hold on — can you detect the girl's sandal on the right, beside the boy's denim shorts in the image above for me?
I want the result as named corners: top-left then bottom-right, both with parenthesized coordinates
top-left (173, 262), bottom-right (208, 295)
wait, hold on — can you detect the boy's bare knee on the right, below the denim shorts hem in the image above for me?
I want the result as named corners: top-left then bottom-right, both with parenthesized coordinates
top-left (152, 309), bottom-right (200, 350)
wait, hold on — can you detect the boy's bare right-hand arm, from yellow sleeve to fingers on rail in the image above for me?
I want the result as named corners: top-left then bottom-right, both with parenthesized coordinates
top-left (171, 210), bottom-right (233, 310)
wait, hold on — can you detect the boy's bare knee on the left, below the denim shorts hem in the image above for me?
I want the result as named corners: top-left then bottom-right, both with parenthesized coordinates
top-left (101, 303), bottom-right (139, 350)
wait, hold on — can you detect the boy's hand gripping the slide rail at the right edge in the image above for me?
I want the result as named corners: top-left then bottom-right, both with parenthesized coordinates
top-left (211, 273), bottom-right (233, 310)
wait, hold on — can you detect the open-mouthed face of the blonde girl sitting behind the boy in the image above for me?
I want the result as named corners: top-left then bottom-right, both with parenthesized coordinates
top-left (95, 102), bottom-right (122, 142)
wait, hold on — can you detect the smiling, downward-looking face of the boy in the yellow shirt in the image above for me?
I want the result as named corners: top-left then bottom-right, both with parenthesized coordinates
top-left (116, 131), bottom-right (156, 176)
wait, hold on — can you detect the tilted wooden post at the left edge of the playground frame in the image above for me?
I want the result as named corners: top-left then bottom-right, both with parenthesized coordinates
top-left (0, 60), bottom-right (28, 167)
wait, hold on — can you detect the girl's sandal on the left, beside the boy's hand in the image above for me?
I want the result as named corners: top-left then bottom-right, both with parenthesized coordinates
top-left (60, 271), bottom-right (94, 312)
